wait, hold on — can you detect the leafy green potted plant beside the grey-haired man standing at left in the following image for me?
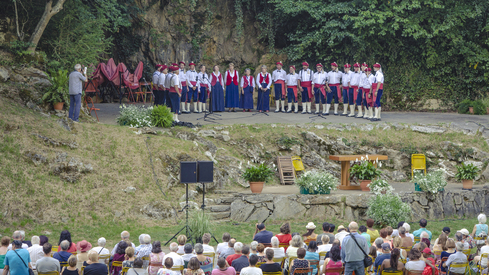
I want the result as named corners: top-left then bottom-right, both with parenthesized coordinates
top-left (42, 70), bottom-right (69, 110)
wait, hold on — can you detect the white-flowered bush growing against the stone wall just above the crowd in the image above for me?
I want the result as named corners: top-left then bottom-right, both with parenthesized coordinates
top-left (367, 193), bottom-right (411, 227)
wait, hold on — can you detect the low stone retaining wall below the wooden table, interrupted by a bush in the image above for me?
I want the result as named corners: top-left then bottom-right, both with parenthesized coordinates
top-left (208, 186), bottom-right (489, 222)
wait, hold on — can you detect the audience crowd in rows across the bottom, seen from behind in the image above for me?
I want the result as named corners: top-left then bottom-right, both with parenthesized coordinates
top-left (0, 214), bottom-right (489, 275)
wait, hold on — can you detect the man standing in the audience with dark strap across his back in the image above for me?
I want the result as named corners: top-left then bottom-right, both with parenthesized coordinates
top-left (341, 222), bottom-right (368, 275)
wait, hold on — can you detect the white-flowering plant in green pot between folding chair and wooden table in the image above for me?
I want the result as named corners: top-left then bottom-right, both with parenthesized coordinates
top-left (295, 171), bottom-right (339, 195)
